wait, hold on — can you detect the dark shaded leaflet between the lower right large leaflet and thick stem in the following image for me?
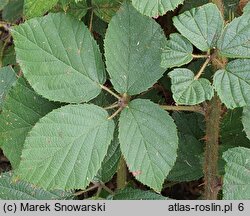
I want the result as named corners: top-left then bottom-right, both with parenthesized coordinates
top-left (167, 133), bottom-right (204, 182)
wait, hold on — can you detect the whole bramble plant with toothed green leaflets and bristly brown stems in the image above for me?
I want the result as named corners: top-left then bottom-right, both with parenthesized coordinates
top-left (0, 0), bottom-right (250, 199)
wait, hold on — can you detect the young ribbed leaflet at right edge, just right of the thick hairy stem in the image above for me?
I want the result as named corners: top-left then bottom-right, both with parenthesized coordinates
top-left (213, 59), bottom-right (250, 109)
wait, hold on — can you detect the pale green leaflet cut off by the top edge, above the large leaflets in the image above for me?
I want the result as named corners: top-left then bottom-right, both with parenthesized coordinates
top-left (132, 0), bottom-right (184, 17)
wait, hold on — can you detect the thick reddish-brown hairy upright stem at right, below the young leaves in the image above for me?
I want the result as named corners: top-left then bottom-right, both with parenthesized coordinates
top-left (204, 95), bottom-right (221, 200)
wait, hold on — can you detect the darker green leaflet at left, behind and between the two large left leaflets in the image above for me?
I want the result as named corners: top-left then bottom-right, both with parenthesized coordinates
top-left (0, 77), bottom-right (57, 169)
